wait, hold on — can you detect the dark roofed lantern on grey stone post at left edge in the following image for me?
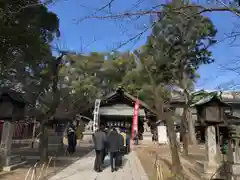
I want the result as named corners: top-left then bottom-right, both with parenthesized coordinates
top-left (0, 89), bottom-right (26, 170)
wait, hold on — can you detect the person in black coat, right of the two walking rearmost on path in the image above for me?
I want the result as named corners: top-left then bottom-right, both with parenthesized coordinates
top-left (107, 128), bottom-right (120, 172)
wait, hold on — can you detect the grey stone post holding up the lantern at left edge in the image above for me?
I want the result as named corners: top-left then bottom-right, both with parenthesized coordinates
top-left (1, 121), bottom-right (14, 157)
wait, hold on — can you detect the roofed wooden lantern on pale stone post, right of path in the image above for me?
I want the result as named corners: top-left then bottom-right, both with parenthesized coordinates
top-left (194, 93), bottom-right (231, 178)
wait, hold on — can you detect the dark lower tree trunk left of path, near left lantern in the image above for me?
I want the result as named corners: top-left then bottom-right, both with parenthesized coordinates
top-left (39, 121), bottom-right (48, 164)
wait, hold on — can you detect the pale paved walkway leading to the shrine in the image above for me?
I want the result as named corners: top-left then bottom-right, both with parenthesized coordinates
top-left (50, 151), bottom-right (148, 180)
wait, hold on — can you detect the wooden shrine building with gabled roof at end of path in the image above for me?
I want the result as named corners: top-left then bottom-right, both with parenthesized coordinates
top-left (99, 88), bottom-right (155, 133)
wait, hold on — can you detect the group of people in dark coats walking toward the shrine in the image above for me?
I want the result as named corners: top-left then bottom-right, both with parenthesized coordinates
top-left (93, 125), bottom-right (130, 172)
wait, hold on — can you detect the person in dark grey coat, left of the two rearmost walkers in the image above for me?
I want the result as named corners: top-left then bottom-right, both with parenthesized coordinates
top-left (93, 126), bottom-right (106, 172)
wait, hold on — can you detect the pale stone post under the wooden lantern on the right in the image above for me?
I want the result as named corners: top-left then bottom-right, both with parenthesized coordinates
top-left (204, 126), bottom-right (218, 174)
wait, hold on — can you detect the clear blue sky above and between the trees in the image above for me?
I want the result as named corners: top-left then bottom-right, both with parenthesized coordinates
top-left (49, 0), bottom-right (240, 90)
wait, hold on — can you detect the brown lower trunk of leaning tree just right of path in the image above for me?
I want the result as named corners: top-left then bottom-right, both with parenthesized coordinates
top-left (166, 115), bottom-right (183, 175)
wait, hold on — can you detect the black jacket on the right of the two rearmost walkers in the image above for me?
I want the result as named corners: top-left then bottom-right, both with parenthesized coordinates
top-left (107, 131), bottom-right (120, 152)
